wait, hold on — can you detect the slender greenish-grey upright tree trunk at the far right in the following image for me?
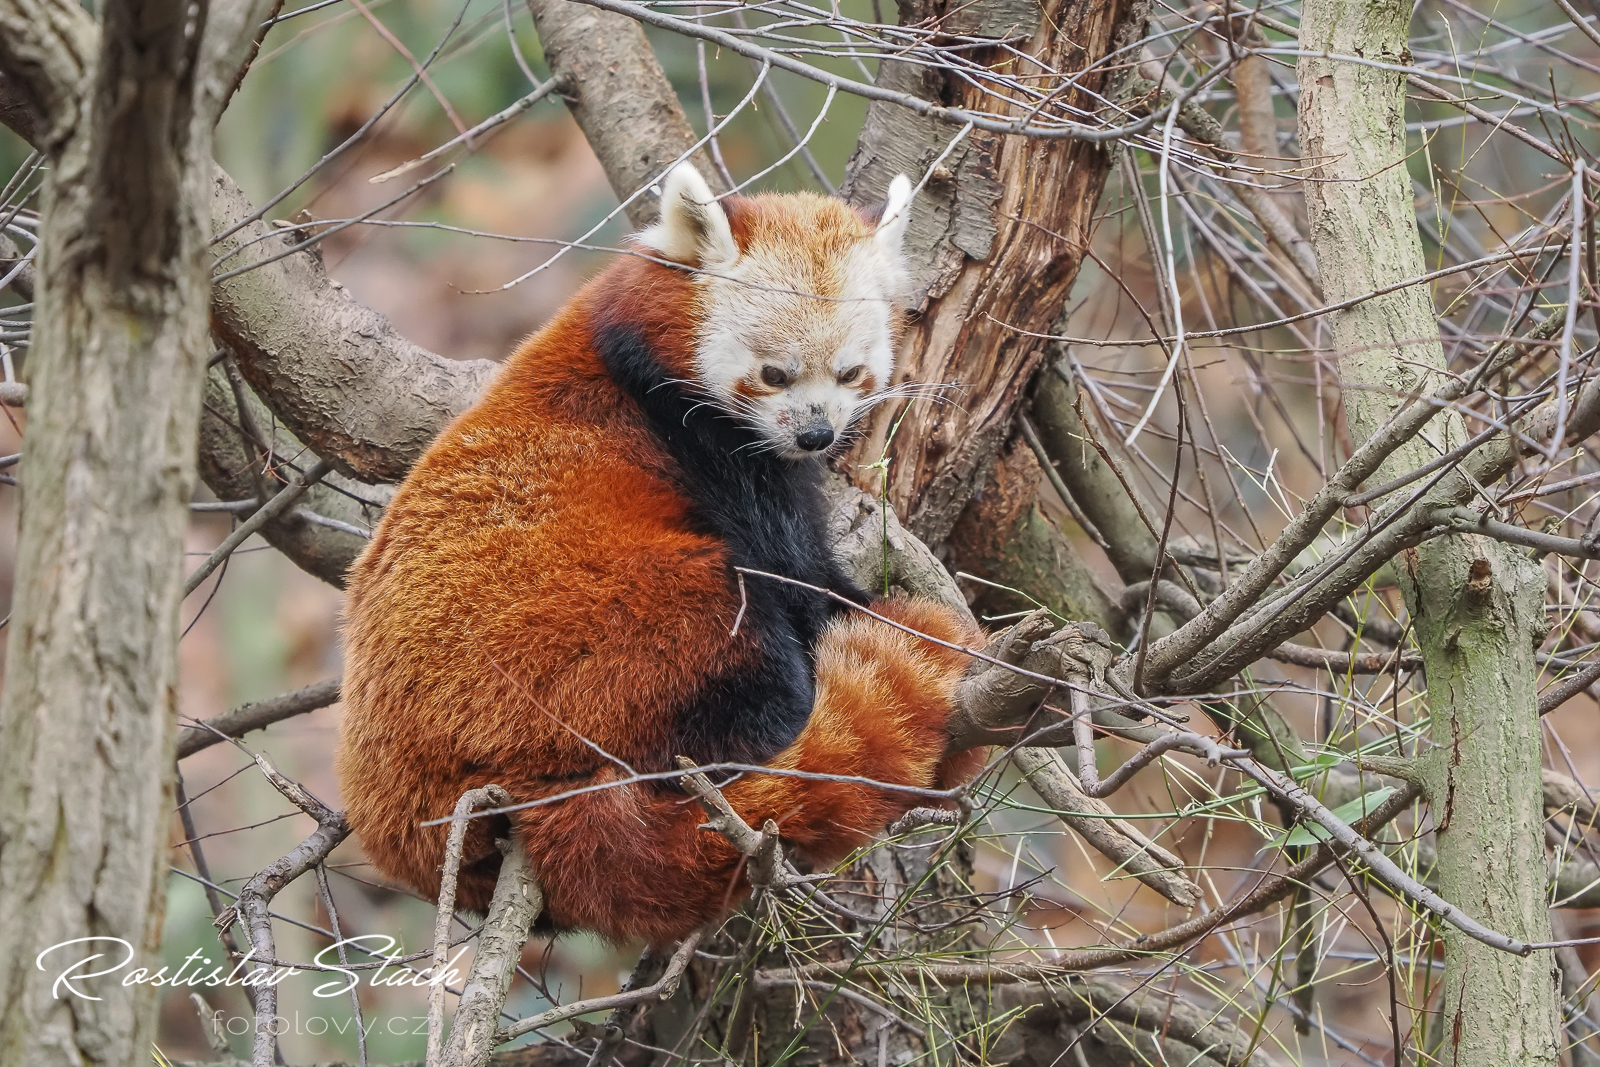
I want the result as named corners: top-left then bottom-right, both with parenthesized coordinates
top-left (1299, 0), bottom-right (1560, 1067)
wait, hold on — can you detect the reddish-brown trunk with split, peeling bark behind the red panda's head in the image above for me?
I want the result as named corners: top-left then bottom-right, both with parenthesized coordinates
top-left (840, 0), bottom-right (1149, 545)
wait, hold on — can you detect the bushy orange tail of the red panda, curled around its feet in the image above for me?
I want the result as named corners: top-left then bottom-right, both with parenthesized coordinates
top-left (505, 598), bottom-right (982, 945)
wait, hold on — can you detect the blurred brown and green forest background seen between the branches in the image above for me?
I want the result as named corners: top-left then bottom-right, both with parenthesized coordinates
top-left (0, 0), bottom-right (1600, 1064)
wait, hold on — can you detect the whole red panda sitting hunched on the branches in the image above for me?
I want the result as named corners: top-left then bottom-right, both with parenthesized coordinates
top-left (338, 165), bottom-right (982, 945)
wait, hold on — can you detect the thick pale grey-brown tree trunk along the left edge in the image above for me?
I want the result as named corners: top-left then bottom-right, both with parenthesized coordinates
top-left (0, 0), bottom-right (272, 1067)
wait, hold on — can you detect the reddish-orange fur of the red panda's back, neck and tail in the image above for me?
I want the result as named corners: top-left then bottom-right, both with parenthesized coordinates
top-left (339, 191), bottom-right (981, 944)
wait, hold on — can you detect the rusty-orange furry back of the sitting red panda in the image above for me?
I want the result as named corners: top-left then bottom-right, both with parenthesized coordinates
top-left (339, 294), bottom-right (738, 894)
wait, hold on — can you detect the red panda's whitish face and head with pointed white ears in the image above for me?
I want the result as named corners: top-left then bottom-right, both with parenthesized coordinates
top-left (638, 163), bottom-right (914, 459)
